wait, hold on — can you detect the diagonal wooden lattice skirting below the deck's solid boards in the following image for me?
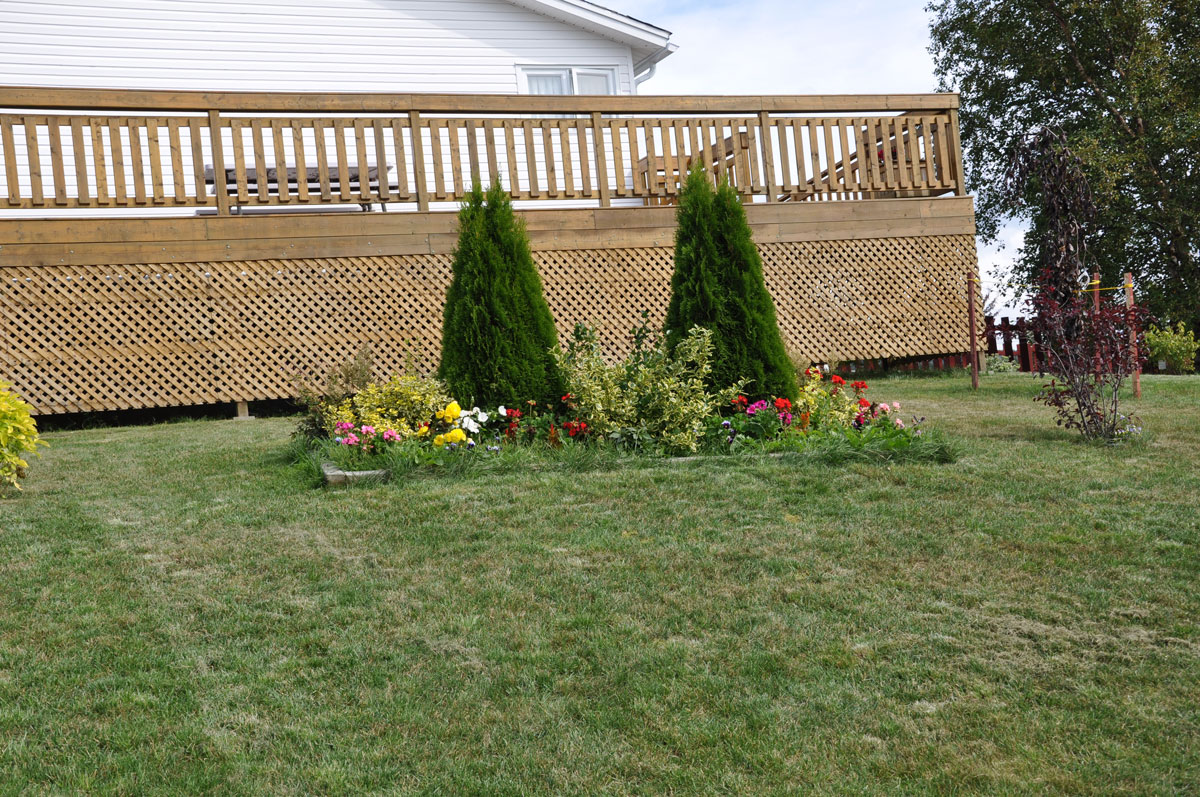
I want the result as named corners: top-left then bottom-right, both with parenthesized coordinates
top-left (0, 235), bottom-right (974, 414)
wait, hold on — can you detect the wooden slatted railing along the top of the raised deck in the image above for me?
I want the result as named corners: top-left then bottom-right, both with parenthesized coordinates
top-left (0, 88), bottom-right (964, 215)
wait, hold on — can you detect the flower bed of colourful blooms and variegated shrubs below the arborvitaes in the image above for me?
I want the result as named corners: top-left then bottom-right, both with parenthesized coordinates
top-left (295, 340), bottom-right (954, 475)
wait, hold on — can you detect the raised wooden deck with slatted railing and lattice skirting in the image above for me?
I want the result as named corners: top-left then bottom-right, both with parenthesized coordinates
top-left (0, 88), bottom-right (982, 413)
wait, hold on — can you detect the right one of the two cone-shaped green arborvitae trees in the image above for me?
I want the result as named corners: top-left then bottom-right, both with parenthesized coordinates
top-left (665, 168), bottom-right (797, 399)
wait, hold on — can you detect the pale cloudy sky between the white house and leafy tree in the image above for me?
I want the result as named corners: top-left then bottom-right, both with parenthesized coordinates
top-left (599, 0), bottom-right (1024, 316)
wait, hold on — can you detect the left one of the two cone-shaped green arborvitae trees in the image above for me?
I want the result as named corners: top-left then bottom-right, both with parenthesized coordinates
top-left (438, 181), bottom-right (563, 406)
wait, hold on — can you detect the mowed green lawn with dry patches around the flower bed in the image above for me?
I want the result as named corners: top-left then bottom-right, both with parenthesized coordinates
top-left (0, 376), bottom-right (1200, 795)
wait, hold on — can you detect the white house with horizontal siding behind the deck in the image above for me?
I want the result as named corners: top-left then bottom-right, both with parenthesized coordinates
top-left (0, 0), bottom-right (676, 94)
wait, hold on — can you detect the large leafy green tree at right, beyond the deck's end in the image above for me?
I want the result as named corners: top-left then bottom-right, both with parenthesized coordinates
top-left (928, 0), bottom-right (1200, 329)
